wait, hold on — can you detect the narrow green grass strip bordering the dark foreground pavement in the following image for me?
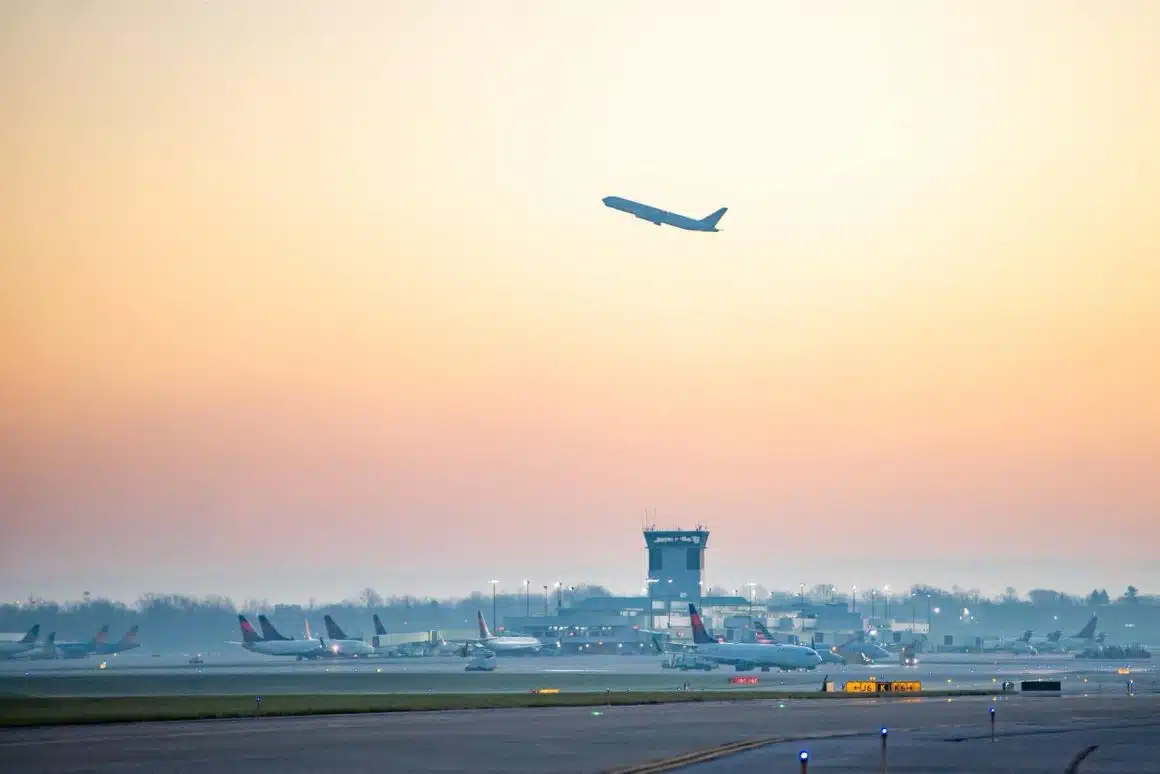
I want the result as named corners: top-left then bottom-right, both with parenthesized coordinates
top-left (0, 690), bottom-right (987, 726)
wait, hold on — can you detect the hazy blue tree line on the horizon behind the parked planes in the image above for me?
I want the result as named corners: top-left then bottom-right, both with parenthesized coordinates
top-left (0, 584), bottom-right (1160, 650)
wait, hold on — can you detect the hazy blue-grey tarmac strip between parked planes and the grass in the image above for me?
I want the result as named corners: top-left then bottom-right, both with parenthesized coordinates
top-left (0, 654), bottom-right (1160, 696)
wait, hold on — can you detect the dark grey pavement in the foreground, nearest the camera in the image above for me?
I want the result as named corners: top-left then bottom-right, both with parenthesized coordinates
top-left (0, 695), bottom-right (1160, 774)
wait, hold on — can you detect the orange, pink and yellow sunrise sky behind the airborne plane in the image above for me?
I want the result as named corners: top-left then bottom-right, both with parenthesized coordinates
top-left (0, 0), bottom-right (1160, 601)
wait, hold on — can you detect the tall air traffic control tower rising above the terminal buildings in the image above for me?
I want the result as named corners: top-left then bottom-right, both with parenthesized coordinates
top-left (644, 525), bottom-right (709, 629)
